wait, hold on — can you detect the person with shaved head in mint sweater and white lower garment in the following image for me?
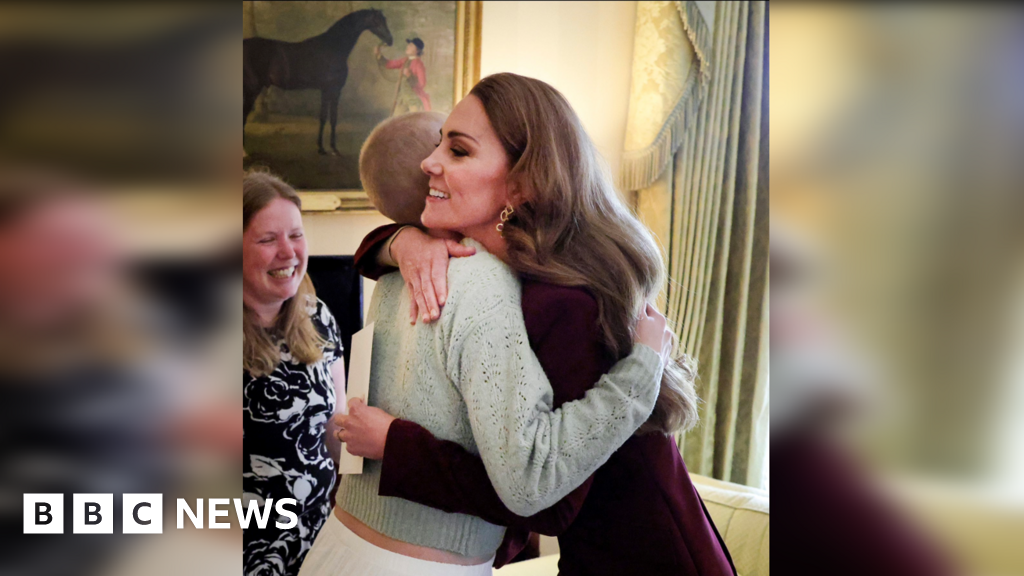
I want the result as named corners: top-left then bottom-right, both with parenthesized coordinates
top-left (300, 106), bottom-right (672, 576)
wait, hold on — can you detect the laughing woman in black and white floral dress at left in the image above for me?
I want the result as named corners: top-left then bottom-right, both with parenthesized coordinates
top-left (242, 171), bottom-right (345, 575)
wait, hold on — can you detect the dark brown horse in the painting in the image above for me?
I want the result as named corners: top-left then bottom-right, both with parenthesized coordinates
top-left (242, 8), bottom-right (392, 154)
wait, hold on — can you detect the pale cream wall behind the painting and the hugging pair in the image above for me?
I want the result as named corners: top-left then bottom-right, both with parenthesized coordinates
top-left (304, 2), bottom-right (636, 313)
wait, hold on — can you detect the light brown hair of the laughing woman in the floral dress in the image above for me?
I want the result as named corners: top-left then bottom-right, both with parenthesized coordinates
top-left (242, 169), bottom-right (332, 377)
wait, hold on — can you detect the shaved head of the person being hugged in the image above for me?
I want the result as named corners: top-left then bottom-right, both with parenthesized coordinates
top-left (359, 112), bottom-right (444, 223)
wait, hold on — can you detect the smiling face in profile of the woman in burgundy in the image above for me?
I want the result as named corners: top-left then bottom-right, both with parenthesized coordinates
top-left (420, 95), bottom-right (509, 243)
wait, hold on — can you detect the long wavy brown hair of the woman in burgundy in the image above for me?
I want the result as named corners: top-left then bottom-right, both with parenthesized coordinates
top-left (470, 73), bottom-right (698, 434)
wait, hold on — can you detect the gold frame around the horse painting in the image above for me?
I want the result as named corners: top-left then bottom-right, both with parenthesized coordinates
top-left (288, 0), bottom-right (483, 213)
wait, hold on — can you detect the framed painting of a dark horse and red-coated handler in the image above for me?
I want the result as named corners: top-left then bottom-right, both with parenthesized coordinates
top-left (242, 1), bottom-right (482, 211)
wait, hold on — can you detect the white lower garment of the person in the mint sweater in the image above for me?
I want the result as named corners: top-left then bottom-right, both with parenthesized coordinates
top-left (299, 513), bottom-right (494, 576)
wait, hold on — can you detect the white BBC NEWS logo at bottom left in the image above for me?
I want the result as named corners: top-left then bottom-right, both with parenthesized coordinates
top-left (24, 494), bottom-right (299, 534)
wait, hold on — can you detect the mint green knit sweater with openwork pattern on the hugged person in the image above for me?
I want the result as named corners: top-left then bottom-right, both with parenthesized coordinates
top-left (337, 240), bottom-right (662, 557)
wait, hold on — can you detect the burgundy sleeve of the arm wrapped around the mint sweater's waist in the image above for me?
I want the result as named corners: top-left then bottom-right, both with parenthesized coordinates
top-left (379, 286), bottom-right (610, 536)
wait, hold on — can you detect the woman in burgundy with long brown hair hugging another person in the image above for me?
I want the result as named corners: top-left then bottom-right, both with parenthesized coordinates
top-left (331, 74), bottom-right (734, 575)
